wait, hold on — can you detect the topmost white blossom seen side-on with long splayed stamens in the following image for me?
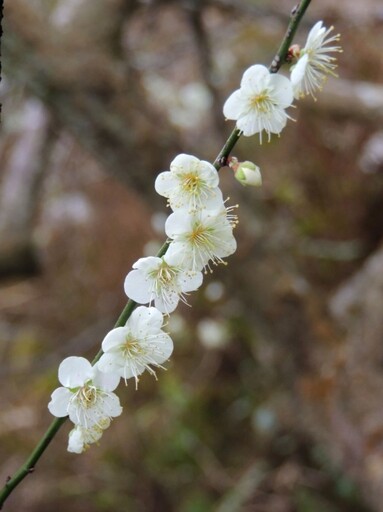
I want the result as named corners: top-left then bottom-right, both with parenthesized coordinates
top-left (291, 21), bottom-right (342, 99)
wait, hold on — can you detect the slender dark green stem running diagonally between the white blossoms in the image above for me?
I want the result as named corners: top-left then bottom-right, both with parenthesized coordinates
top-left (0, 0), bottom-right (311, 509)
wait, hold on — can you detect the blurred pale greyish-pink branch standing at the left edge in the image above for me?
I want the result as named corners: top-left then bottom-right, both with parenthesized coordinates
top-left (0, 100), bottom-right (55, 276)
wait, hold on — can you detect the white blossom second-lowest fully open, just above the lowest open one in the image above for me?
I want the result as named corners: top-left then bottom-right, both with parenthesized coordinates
top-left (98, 306), bottom-right (173, 388)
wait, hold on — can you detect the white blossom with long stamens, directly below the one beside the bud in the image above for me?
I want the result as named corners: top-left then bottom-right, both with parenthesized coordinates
top-left (165, 207), bottom-right (237, 270)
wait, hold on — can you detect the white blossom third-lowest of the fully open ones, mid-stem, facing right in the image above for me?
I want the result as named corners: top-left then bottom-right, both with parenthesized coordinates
top-left (124, 254), bottom-right (203, 314)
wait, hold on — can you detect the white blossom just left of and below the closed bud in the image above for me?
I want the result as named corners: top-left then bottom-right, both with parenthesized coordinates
top-left (155, 154), bottom-right (223, 211)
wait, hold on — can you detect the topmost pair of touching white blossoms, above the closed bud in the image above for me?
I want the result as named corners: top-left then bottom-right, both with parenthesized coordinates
top-left (223, 21), bottom-right (342, 143)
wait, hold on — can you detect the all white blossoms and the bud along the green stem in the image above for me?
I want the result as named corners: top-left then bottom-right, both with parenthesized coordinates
top-left (48, 21), bottom-right (341, 453)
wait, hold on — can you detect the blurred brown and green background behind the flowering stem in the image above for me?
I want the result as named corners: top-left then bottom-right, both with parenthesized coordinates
top-left (0, 0), bottom-right (383, 512)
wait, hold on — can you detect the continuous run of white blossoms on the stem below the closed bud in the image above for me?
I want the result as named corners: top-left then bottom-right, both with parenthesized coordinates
top-left (48, 154), bottom-right (237, 453)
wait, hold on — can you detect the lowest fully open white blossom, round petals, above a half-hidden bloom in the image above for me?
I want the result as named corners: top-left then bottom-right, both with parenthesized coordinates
top-left (48, 356), bottom-right (122, 429)
